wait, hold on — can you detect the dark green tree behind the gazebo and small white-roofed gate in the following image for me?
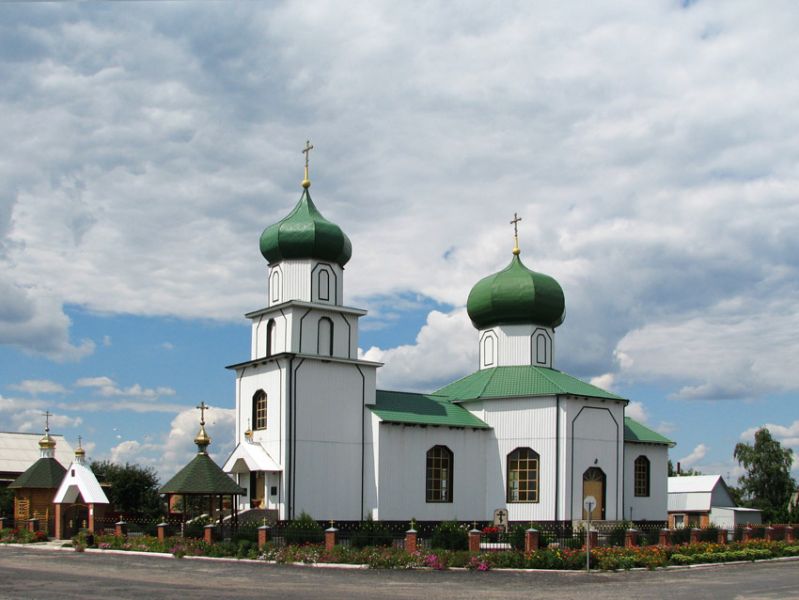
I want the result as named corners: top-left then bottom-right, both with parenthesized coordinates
top-left (91, 460), bottom-right (164, 518)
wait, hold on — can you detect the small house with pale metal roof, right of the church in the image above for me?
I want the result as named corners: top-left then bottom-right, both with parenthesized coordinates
top-left (668, 475), bottom-right (763, 529)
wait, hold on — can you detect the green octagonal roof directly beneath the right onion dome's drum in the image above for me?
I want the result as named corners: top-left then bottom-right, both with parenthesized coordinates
top-left (435, 365), bottom-right (624, 401)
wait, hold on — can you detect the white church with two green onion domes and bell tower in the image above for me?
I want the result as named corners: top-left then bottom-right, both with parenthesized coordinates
top-left (224, 161), bottom-right (673, 523)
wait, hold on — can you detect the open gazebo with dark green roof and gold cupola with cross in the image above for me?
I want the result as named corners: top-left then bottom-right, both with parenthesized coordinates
top-left (159, 402), bottom-right (246, 528)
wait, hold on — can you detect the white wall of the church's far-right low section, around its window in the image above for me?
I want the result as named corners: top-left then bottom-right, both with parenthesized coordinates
top-left (624, 442), bottom-right (669, 521)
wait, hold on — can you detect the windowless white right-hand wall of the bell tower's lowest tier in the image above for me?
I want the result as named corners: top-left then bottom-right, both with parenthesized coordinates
top-left (292, 358), bottom-right (374, 520)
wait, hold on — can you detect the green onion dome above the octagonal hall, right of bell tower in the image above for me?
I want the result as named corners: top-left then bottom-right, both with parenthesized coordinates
top-left (466, 252), bottom-right (566, 329)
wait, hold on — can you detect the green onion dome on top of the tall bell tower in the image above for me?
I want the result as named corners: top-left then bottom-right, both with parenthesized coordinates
top-left (261, 187), bottom-right (352, 267)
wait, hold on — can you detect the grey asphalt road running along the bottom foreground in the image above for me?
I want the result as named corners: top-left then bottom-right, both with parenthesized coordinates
top-left (0, 546), bottom-right (799, 600)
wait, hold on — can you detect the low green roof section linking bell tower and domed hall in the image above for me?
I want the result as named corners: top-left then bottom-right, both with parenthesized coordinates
top-left (368, 390), bottom-right (489, 429)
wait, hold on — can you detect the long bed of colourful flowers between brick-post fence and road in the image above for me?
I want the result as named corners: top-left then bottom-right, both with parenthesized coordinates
top-left (73, 535), bottom-right (799, 571)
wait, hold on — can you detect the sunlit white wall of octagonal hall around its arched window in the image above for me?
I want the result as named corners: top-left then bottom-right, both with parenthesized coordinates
top-left (478, 396), bottom-right (556, 521)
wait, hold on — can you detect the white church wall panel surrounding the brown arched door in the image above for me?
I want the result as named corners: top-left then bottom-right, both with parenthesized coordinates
top-left (561, 398), bottom-right (624, 520)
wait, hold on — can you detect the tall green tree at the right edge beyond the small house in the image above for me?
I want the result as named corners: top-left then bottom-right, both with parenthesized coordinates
top-left (733, 427), bottom-right (796, 522)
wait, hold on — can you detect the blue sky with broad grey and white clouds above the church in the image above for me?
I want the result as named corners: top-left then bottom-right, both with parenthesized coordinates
top-left (0, 0), bottom-right (799, 480)
